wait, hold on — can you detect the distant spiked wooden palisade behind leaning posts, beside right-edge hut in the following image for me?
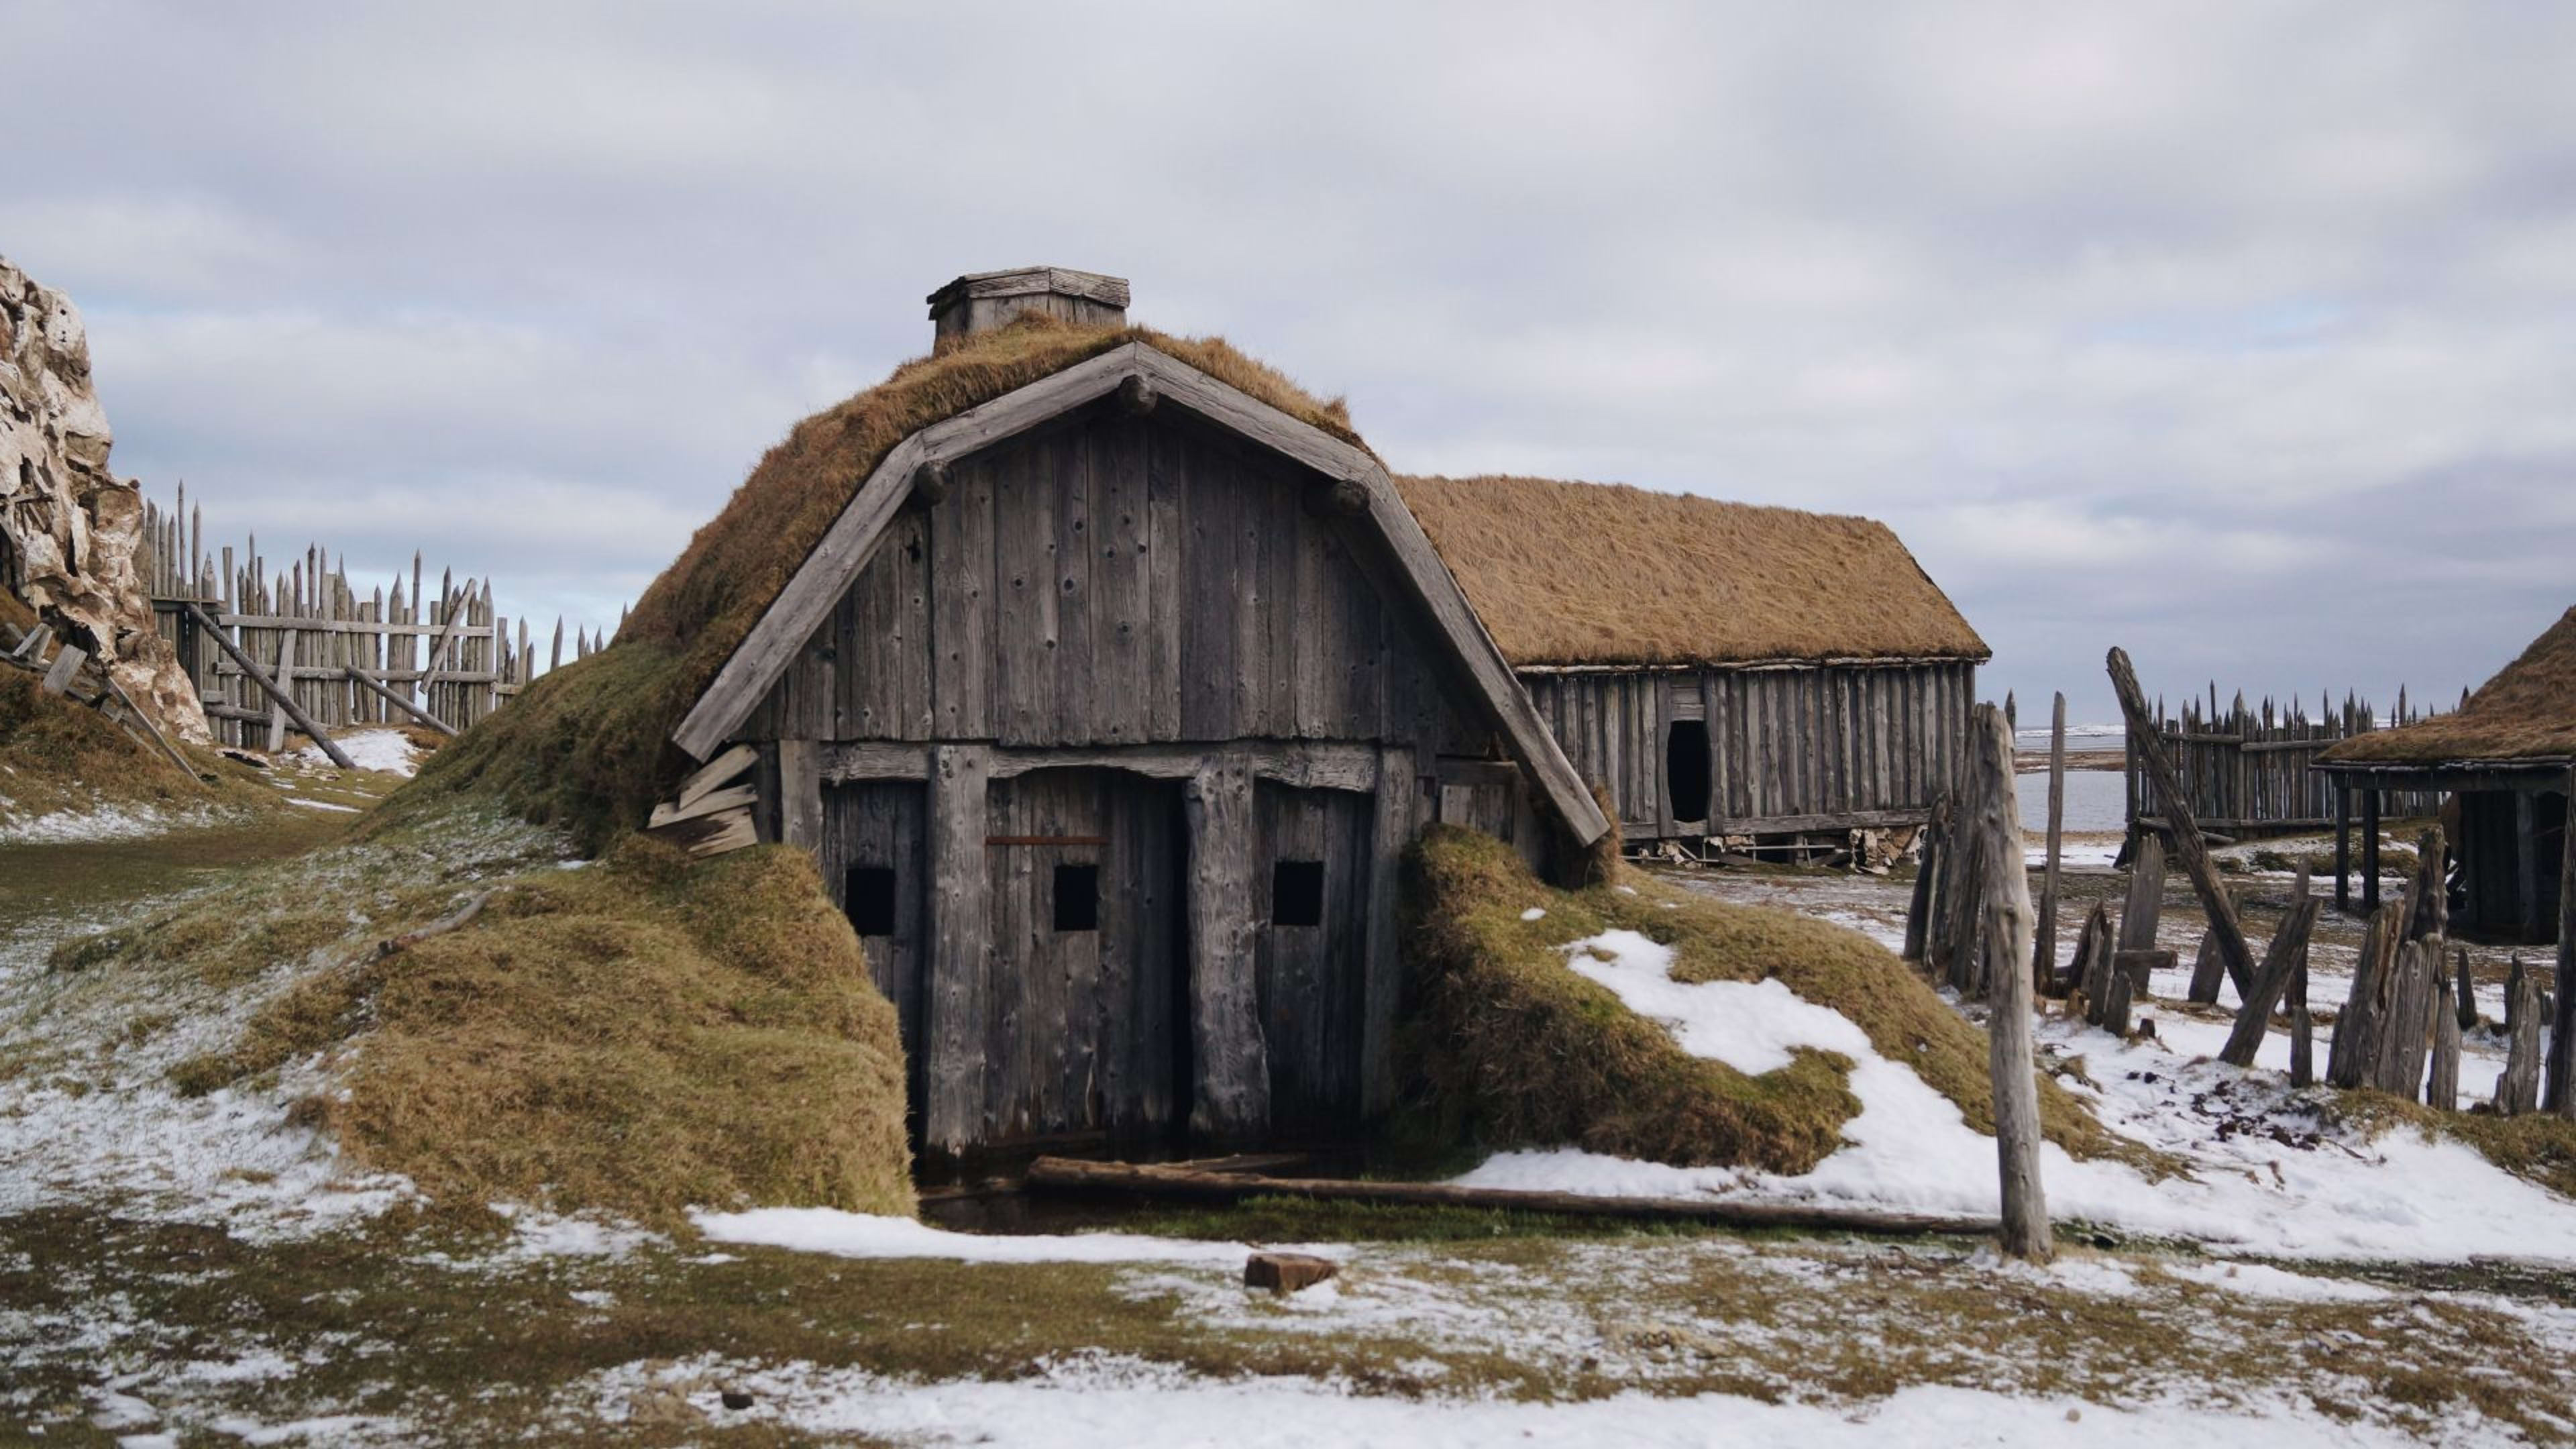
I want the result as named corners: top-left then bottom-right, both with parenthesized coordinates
top-left (2125, 684), bottom-right (2442, 838)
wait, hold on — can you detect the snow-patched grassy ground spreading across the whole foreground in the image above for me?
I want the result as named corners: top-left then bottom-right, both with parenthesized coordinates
top-left (0, 799), bottom-right (2576, 1449)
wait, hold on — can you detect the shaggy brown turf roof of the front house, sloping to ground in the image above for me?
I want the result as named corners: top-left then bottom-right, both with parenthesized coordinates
top-left (386, 315), bottom-right (1360, 848)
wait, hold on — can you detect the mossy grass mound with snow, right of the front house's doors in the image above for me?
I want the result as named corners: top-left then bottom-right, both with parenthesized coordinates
top-left (1404, 828), bottom-right (2171, 1176)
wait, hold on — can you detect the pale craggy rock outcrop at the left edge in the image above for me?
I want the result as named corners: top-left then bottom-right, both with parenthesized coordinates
top-left (0, 258), bottom-right (206, 743)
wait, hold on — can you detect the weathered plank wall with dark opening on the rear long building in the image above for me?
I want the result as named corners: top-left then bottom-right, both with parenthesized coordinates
top-left (1522, 660), bottom-right (1976, 843)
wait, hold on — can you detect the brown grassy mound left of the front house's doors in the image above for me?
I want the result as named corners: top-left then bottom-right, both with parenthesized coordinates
top-left (158, 835), bottom-right (912, 1225)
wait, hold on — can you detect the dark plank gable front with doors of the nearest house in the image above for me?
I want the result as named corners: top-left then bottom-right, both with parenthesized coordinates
top-left (737, 405), bottom-right (1504, 1158)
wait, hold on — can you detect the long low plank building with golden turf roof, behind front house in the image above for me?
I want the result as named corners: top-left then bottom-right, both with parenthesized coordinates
top-left (1396, 477), bottom-right (1988, 846)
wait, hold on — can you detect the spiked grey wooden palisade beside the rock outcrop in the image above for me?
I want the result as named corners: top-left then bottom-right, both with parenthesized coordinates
top-left (137, 490), bottom-right (608, 750)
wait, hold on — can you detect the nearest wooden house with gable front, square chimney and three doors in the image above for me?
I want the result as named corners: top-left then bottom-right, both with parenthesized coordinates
top-left (657, 268), bottom-right (1610, 1158)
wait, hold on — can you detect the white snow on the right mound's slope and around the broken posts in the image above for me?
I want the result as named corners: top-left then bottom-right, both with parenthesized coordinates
top-left (1460, 912), bottom-right (2576, 1266)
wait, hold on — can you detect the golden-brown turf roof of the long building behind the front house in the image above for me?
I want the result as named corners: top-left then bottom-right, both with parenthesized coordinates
top-left (1396, 477), bottom-right (1988, 665)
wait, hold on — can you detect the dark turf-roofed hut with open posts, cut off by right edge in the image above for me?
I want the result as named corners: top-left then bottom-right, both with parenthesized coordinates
top-left (2310, 608), bottom-right (2576, 943)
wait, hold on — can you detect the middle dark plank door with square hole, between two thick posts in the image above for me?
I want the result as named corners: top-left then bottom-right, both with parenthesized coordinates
top-left (984, 768), bottom-right (1190, 1147)
